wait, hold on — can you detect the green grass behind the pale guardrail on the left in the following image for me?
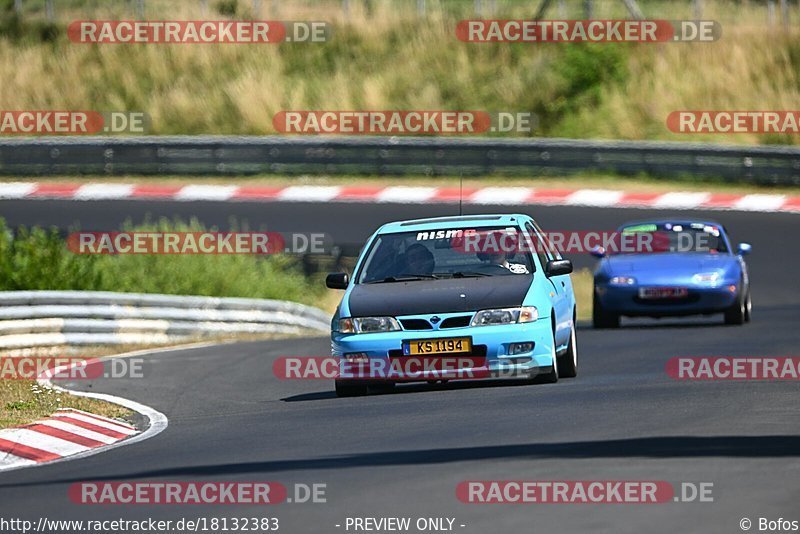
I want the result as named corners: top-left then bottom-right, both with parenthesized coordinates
top-left (0, 219), bottom-right (324, 304)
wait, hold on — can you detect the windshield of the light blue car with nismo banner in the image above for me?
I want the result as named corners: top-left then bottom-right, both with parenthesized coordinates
top-left (357, 228), bottom-right (535, 284)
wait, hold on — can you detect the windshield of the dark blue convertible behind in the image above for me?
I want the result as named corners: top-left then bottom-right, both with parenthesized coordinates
top-left (610, 222), bottom-right (728, 254)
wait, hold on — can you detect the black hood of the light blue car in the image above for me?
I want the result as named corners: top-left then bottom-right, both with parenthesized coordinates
top-left (349, 275), bottom-right (533, 317)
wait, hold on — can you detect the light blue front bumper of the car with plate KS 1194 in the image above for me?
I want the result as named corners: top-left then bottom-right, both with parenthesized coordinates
top-left (331, 317), bottom-right (554, 382)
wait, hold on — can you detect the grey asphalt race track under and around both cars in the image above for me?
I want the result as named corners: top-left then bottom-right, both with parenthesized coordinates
top-left (0, 201), bottom-right (800, 533)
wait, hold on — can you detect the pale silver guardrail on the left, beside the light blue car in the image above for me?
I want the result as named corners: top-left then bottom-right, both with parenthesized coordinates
top-left (0, 291), bottom-right (330, 349)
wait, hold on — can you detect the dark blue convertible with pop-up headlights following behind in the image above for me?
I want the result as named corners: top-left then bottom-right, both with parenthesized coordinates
top-left (593, 220), bottom-right (751, 328)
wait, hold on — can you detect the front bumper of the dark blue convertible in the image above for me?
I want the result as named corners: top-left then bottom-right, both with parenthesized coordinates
top-left (594, 283), bottom-right (741, 317)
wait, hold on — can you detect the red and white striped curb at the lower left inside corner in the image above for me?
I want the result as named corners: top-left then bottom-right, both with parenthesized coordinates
top-left (0, 408), bottom-right (139, 470)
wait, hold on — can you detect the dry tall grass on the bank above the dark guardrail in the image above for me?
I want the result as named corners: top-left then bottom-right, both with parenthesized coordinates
top-left (0, 0), bottom-right (800, 143)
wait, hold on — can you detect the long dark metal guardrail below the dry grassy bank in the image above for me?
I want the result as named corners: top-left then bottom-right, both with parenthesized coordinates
top-left (0, 136), bottom-right (800, 185)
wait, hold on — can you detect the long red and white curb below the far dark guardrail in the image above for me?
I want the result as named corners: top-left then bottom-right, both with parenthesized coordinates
top-left (0, 182), bottom-right (800, 213)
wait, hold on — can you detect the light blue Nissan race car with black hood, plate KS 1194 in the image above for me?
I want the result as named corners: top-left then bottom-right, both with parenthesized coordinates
top-left (326, 215), bottom-right (578, 397)
